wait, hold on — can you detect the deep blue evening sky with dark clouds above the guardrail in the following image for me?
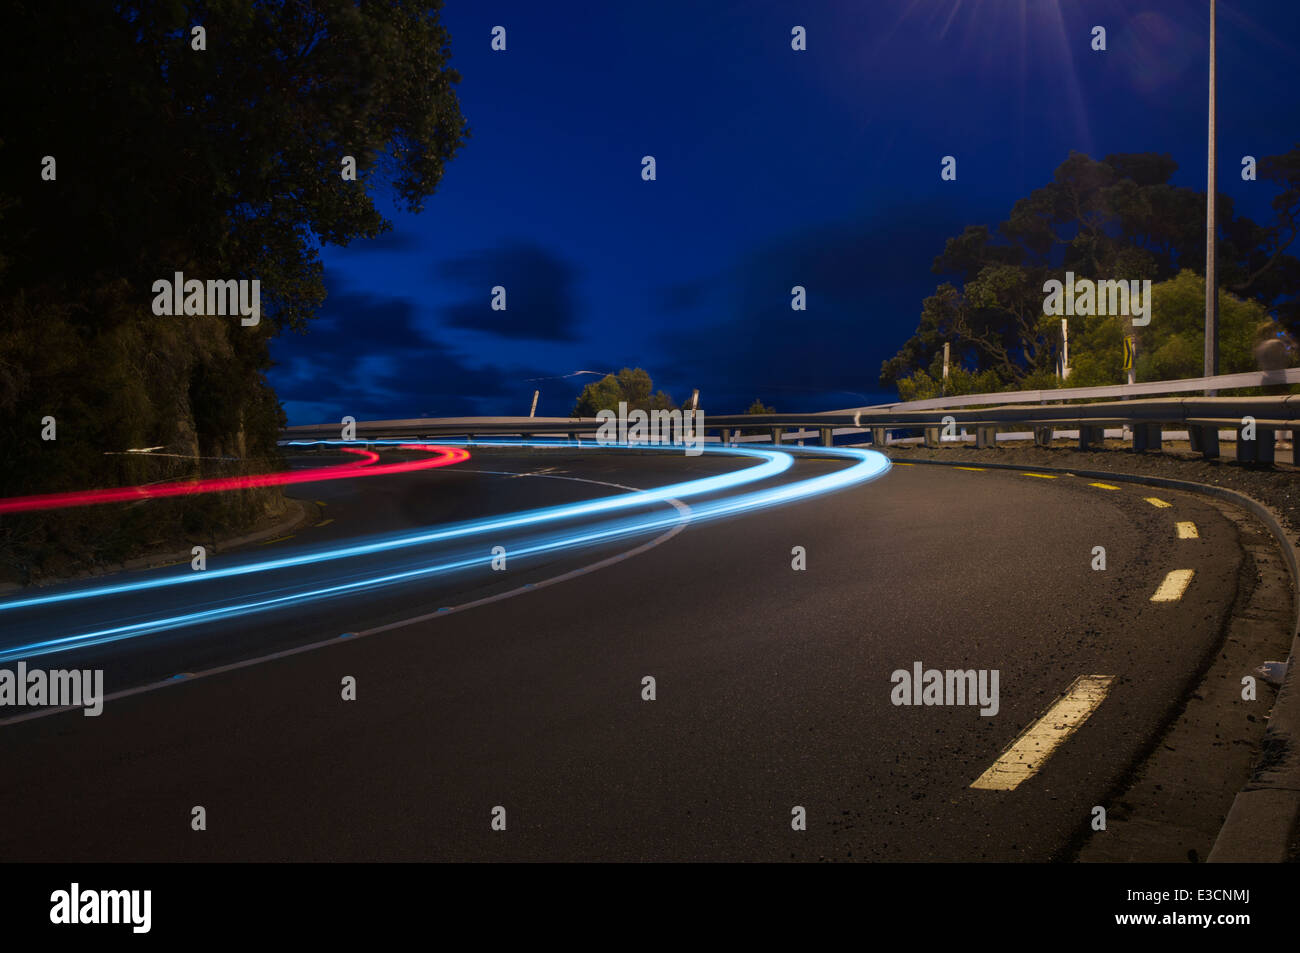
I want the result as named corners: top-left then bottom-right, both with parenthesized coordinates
top-left (270, 0), bottom-right (1300, 424)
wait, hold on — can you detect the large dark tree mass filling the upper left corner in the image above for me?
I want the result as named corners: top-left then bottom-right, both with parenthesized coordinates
top-left (0, 0), bottom-right (468, 577)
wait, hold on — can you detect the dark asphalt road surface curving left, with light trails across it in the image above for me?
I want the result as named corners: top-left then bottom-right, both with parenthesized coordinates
top-left (0, 447), bottom-right (1242, 861)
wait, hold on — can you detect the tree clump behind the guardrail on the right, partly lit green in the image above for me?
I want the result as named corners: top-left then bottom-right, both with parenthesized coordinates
top-left (880, 146), bottom-right (1300, 397)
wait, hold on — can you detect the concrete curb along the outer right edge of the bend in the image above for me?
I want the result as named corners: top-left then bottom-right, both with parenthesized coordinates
top-left (889, 456), bottom-right (1300, 863)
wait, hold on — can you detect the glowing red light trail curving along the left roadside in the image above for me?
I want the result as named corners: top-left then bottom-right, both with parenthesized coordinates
top-left (0, 443), bottom-right (469, 514)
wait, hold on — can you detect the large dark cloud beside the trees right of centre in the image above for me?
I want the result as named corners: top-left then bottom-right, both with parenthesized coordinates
top-left (655, 198), bottom-right (963, 412)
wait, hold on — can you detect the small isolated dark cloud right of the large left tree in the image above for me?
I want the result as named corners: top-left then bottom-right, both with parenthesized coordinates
top-left (437, 242), bottom-right (577, 342)
